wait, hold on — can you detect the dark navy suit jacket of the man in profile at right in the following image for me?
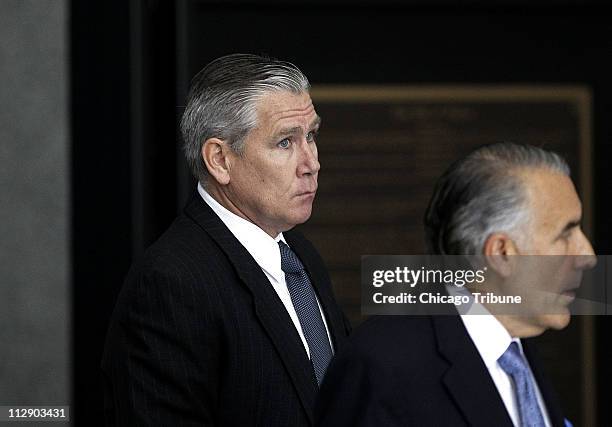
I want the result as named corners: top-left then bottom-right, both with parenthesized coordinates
top-left (316, 316), bottom-right (563, 427)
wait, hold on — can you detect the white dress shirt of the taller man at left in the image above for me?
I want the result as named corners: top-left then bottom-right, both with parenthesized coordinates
top-left (198, 184), bottom-right (334, 358)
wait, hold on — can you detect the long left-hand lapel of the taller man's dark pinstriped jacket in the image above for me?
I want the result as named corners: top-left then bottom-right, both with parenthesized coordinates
top-left (185, 194), bottom-right (318, 422)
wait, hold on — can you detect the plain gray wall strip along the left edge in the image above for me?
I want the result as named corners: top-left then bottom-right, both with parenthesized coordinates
top-left (0, 0), bottom-right (70, 414)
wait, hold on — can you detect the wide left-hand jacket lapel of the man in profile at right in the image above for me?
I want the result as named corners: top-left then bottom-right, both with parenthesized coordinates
top-left (432, 315), bottom-right (513, 427)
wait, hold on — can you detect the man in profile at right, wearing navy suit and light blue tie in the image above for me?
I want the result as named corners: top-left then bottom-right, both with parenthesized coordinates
top-left (316, 143), bottom-right (595, 427)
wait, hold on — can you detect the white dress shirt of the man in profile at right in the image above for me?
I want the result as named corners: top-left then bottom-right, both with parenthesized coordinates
top-left (448, 286), bottom-right (551, 427)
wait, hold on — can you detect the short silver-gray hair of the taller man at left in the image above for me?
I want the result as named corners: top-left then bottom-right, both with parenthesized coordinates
top-left (181, 54), bottom-right (310, 185)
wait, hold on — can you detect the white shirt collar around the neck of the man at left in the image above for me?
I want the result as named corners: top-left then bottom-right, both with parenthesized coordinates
top-left (198, 183), bottom-right (287, 281)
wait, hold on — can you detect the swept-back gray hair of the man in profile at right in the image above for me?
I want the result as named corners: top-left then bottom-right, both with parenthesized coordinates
top-left (425, 143), bottom-right (570, 255)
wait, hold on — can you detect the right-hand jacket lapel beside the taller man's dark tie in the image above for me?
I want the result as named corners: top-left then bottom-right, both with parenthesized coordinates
top-left (283, 231), bottom-right (346, 352)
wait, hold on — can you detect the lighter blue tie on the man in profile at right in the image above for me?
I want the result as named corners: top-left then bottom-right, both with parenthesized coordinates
top-left (497, 341), bottom-right (546, 427)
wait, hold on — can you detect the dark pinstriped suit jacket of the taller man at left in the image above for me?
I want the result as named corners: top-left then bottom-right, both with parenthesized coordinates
top-left (102, 194), bottom-right (348, 426)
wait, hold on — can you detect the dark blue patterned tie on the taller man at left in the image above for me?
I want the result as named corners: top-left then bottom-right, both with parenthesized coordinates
top-left (278, 241), bottom-right (332, 384)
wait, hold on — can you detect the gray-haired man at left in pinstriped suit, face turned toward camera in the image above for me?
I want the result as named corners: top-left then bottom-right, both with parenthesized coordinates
top-left (102, 54), bottom-right (349, 426)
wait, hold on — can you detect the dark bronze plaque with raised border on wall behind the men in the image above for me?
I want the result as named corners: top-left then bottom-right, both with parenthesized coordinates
top-left (302, 85), bottom-right (591, 323)
